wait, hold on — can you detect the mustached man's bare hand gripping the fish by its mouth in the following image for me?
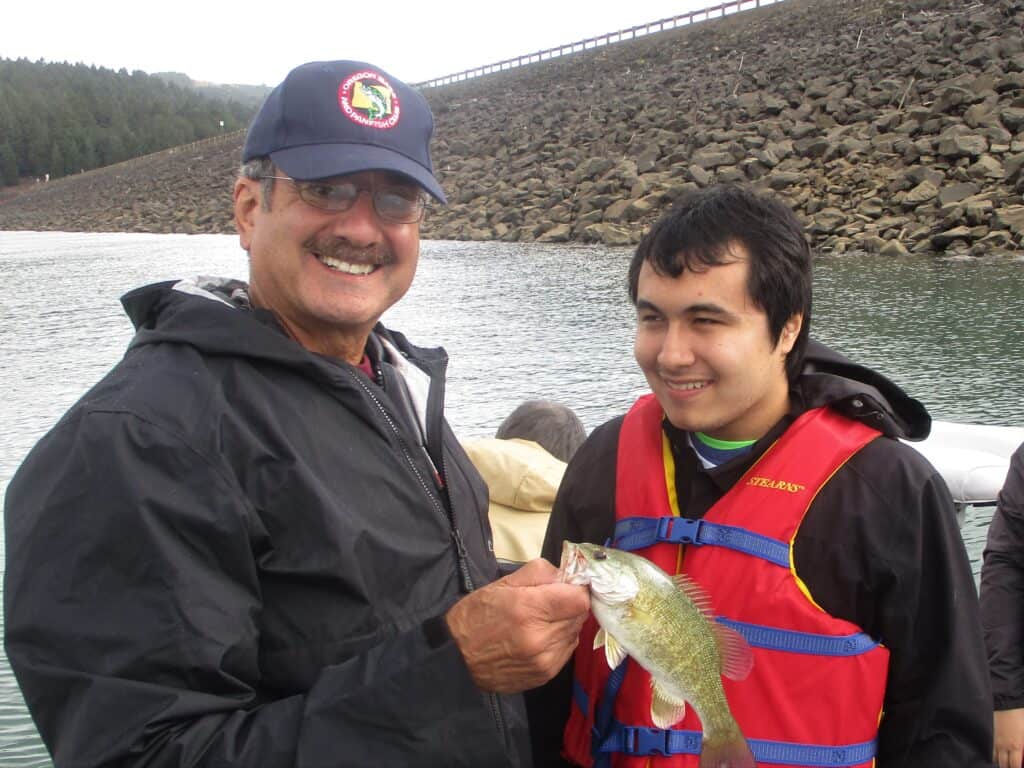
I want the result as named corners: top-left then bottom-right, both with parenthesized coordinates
top-left (444, 558), bottom-right (590, 693)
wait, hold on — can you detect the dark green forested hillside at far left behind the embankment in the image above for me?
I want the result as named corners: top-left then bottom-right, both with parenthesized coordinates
top-left (0, 58), bottom-right (256, 186)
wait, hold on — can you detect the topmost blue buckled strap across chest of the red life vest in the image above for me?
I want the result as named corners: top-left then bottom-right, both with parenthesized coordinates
top-left (611, 516), bottom-right (790, 568)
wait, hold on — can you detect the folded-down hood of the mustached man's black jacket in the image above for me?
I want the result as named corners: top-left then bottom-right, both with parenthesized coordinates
top-left (121, 278), bottom-right (447, 374)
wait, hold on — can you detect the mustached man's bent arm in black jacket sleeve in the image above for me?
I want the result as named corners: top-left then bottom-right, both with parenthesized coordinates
top-left (5, 413), bottom-right (497, 768)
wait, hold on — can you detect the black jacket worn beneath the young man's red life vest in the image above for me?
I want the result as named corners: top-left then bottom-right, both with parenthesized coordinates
top-left (527, 342), bottom-right (992, 768)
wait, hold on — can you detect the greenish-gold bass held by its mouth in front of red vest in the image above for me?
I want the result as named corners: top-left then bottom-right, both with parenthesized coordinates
top-left (559, 541), bottom-right (755, 768)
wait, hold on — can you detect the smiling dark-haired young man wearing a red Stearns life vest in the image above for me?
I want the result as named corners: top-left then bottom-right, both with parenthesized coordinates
top-left (530, 186), bottom-right (991, 768)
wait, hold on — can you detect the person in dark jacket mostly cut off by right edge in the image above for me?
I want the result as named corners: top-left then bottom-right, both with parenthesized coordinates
top-left (981, 445), bottom-right (1024, 768)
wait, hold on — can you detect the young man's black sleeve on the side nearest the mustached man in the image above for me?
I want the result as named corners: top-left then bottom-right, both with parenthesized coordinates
top-left (525, 419), bottom-right (622, 768)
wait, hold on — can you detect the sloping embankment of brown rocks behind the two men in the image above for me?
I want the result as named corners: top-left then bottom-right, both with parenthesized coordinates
top-left (0, 0), bottom-right (1024, 256)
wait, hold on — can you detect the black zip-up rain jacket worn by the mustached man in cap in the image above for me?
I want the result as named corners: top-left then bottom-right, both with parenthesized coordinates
top-left (5, 284), bottom-right (529, 768)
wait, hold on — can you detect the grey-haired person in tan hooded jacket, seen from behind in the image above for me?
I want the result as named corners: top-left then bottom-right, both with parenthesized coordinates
top-left (464, 400), bottom-right (587, 572)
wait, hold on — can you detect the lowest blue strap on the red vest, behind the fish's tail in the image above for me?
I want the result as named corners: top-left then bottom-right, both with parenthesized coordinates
top-left (595, 721), bottom-right (878, 768)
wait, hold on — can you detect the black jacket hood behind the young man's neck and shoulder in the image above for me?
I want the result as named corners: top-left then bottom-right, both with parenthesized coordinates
top-left (799, 339), bottom-right (932, 440)
